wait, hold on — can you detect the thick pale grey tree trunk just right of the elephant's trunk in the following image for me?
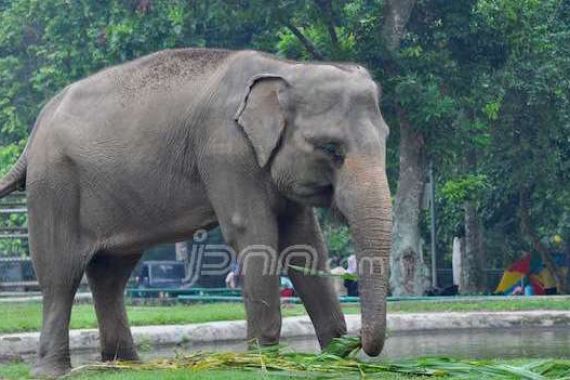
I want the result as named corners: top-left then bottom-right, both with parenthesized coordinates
top-left (390, 109), bottom-right (429, 296)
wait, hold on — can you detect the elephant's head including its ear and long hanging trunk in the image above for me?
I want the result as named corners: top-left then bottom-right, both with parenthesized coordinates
top-left (236, 65), bottom-right (391, 356)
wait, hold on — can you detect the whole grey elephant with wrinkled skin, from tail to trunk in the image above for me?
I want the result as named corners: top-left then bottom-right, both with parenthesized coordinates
top-left (0, 49), bottom-right (391, 376)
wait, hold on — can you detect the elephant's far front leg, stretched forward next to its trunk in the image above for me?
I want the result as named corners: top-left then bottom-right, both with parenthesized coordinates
top-left (279, 206), bottom-right (346, 348)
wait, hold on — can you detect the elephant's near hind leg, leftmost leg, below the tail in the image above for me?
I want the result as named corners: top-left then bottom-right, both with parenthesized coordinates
top-left (28, 180), bottom-right (92, 377)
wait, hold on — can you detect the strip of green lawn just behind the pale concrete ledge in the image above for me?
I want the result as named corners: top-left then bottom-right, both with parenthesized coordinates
top-left (0, 297), bottom-right (570, 333)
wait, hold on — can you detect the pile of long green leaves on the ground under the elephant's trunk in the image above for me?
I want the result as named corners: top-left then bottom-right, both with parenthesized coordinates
top-left (69, 337), bottom-right (570, 380)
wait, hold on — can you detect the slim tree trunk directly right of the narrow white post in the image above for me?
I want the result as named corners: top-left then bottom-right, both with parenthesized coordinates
top-left (459, 201), bottom-right (486, 294)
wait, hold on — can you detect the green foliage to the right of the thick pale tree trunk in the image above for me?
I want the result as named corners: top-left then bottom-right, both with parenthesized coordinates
top-left (397, 0), bottom-right (570, 267)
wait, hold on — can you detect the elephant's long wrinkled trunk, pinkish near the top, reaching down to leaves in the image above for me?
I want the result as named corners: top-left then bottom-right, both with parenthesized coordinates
top-left (335, 158), bottom-right (392, 356)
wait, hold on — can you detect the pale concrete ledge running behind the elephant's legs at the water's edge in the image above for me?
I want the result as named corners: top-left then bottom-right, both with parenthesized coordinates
top-left (0, 310), bottom-right (570, 359)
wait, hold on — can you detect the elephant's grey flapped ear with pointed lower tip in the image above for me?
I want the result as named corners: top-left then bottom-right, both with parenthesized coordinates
top-left (235, 74), bottom-right (288, 167)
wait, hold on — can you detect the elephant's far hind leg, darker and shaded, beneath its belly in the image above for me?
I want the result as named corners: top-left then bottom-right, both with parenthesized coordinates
top-left (87, 253), bottom-right (141, 361)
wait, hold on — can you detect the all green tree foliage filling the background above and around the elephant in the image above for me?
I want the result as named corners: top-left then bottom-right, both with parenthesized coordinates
top-left (0, 0), bottom-right (570, 274)
